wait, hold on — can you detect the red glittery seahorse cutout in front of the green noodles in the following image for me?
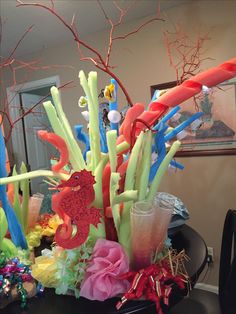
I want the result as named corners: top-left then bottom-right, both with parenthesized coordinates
top-left (52, 170), bottom-right (101, 249)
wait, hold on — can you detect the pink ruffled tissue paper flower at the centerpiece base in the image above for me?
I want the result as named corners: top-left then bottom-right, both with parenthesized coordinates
top-left (80, 239), bottom-right (130, 301)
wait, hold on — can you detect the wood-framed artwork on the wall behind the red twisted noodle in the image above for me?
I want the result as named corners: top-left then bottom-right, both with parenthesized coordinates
top-left (151, 78), bottom-right (236, 157)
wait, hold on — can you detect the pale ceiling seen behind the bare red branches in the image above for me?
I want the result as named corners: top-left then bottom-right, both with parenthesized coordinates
top-left (0, 0), bottom-right (188, 57)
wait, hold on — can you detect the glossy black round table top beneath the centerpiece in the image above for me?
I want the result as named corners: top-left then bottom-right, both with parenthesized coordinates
top-left (0, 225), bottom-right (207, 314)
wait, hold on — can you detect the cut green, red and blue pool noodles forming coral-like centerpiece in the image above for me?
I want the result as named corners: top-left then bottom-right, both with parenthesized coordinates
top-left (0, 58), bottom-right (236, 255)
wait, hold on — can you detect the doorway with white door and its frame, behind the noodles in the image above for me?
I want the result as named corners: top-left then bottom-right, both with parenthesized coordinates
top-left (7, 76), bottom-right (59, 194)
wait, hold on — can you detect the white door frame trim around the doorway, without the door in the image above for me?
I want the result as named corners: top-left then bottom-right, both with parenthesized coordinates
top-left (6, 75), bottom-right (60, 169)
